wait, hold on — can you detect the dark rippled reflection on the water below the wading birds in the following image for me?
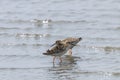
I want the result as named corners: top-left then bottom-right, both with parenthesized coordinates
top-left (49, 55), bottom-right (81, 80)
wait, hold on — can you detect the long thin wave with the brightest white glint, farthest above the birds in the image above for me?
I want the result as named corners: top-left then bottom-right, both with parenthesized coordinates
top-left (0, 19), bottom-right (91, 24)
